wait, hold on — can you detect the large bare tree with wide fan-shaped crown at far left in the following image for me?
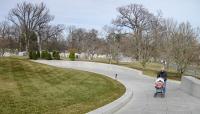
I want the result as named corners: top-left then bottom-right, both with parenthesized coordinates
top-left (8, 2), bottom-right (53, 51)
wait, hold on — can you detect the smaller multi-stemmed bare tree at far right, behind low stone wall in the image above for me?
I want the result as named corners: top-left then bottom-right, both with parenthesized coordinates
top-left (171, 23), bottom-right (198, 75)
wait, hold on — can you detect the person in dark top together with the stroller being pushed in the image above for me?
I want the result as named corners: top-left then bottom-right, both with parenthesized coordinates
top-left (154, 67), bottom-right (167, 97)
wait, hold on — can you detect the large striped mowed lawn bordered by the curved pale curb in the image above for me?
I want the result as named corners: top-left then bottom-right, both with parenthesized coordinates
top-left (0, 58), bottom-right (125, 114)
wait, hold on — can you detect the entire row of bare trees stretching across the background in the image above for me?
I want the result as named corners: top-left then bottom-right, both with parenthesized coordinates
top-left (0, 2), bottom-right (200, 74)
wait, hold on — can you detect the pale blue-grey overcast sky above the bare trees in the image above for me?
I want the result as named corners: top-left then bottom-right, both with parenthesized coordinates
top-left (0, 0), bottom-right (200, 30)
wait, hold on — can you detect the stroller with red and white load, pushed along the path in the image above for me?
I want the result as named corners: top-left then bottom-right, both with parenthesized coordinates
top-left (154, 78), bottom-right (165, 97)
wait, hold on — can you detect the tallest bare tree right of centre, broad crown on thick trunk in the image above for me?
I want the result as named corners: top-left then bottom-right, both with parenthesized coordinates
top-left (113, 4), bottom-right (153, 60)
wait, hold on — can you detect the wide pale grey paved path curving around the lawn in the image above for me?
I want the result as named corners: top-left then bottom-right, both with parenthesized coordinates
top-left (37, 60), bottom-right (200, 114)
